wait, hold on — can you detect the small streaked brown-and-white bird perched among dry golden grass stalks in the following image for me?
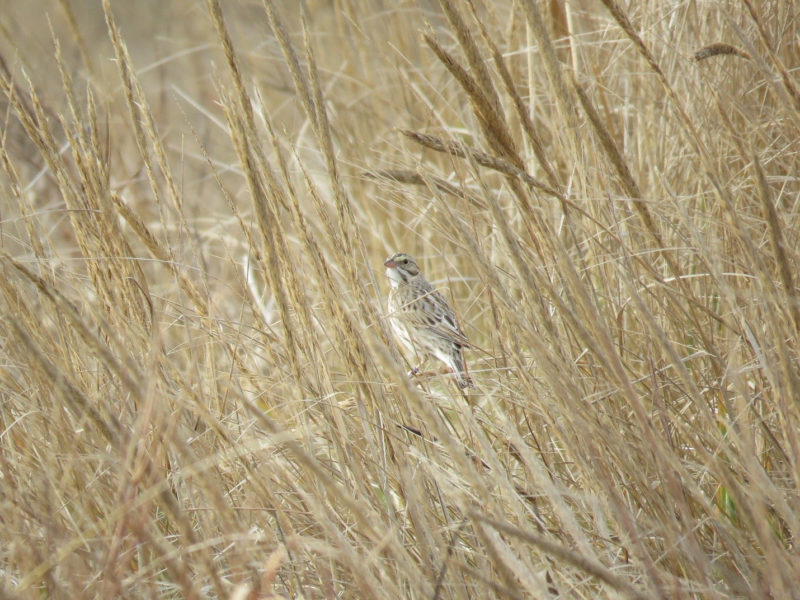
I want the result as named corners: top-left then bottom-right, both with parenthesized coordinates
top-left (383, 252), bottom-right (472, 388)
